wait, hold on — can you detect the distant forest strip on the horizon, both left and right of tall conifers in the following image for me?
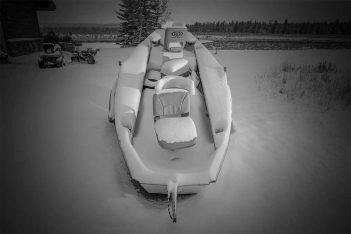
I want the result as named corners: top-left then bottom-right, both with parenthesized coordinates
top-left (41, 20), bottom-right (351, 36)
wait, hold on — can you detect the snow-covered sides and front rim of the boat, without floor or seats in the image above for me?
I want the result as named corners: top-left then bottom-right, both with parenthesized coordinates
top-left (109, 26), bottom-right (232, 194)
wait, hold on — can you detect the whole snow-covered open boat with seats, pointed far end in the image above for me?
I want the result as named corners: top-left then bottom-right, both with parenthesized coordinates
top-left (108, 23), bottom-right (233, 222)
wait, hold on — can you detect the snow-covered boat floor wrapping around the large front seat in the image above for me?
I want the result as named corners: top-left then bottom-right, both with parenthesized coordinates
top-left (133, 89), bottom-right (215, 171)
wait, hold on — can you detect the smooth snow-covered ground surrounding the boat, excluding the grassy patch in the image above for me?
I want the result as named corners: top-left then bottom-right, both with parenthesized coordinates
top-left (0, 47), bottom-right (351, 233)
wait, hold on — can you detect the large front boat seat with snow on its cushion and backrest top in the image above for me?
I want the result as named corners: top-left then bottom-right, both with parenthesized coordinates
top-left (153, 76), bottom-right (197, 150)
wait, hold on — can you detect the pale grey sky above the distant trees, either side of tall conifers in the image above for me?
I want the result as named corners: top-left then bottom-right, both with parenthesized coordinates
top-left (38, 0), bottom-right (351, 25)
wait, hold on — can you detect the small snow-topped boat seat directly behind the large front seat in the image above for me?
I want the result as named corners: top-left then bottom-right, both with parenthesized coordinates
top-left (161, 58), bottom-right (190, 77)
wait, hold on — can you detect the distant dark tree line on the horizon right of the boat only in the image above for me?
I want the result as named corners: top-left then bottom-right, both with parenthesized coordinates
top-left (187, 20), bottom-right (351, 35)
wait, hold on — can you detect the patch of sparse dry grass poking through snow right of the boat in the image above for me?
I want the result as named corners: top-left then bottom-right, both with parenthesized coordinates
top-left (258, 61), bottom-right (351, 110)
